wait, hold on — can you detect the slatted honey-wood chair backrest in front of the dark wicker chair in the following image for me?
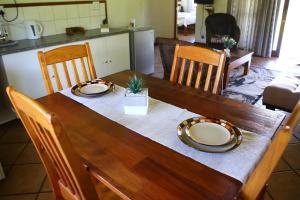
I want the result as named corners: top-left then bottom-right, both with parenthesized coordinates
top-left (170, 44), bottom-right (226, 94)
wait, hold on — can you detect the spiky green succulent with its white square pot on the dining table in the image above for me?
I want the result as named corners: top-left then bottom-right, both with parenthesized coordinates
top-left (124, 75), bottom-right (148, 115)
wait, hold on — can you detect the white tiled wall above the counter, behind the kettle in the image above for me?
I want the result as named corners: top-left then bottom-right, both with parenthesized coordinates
top-left (1, 0), bottom-right (105, 40)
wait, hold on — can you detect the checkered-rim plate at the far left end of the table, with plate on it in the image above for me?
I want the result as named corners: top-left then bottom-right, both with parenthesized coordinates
top-left (71, 79), bottom-right (114, 97)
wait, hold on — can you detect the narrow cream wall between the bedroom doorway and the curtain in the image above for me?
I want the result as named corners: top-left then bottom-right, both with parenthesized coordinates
top-left (195, 0), bottom-right (228, 42)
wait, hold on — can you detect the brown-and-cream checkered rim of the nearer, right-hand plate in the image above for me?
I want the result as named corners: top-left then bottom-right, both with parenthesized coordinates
top-left (177, 118), bottom-right (243, 153)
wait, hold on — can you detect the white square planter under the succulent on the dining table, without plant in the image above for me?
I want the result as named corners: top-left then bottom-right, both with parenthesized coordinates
top-left (124, 88), bottom-right (149, 115)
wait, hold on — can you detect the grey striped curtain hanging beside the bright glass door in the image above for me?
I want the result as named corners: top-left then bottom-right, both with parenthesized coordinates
top-left (230, 0), bottom-right (281, 57)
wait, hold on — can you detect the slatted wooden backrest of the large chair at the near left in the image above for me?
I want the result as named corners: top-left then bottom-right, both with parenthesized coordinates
top-left (6, 87), bottom-right (98, 200)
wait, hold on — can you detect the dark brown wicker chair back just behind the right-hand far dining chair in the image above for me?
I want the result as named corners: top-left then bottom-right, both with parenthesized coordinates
top-left (156, 38), bottom-right (193, 80)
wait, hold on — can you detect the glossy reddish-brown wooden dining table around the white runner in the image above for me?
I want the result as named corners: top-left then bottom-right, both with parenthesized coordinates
top-left (38, 71), bottom-right (285, 200)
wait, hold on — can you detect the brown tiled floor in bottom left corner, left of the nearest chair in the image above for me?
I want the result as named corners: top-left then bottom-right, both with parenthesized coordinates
top-left (0, 120), bottom-right (54, 200)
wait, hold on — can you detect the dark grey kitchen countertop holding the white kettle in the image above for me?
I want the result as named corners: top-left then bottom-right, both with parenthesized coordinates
top-left (0, 27), bottom-right (152, 56)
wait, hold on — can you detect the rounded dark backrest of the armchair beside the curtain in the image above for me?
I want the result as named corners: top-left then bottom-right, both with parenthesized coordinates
top-left (205, 13), bottom-right (240, 47)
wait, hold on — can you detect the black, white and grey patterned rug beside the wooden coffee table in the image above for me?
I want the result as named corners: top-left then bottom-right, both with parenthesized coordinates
top-left (222, 66), bottom-right (279, 105)
